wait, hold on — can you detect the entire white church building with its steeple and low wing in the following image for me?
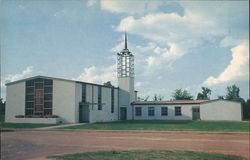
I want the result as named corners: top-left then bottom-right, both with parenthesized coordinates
top-left (5, 33), bottom-right (242, 123)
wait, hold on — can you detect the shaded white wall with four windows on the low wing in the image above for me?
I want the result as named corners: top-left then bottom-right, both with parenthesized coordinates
top-left (134, 105), bottom-right (199, 120)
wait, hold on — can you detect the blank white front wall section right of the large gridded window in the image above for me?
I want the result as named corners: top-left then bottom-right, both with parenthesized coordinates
top-left (52, 80), bottom-right (78, 123)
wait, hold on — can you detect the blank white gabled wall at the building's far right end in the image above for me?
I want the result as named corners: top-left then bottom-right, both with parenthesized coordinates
top-left (200, 100), bottom-right (242, 121)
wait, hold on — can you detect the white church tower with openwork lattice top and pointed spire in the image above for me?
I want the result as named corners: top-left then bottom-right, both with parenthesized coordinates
top-left (117, 32), bottom-right (135, 120)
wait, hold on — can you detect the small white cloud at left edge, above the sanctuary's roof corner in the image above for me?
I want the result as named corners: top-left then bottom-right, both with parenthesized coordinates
top-left (1, 66), bottom-right (33, 87)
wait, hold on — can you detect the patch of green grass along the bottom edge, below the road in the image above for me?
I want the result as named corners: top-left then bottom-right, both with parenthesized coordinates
top-left (48, 151), bottom-right (247, 160)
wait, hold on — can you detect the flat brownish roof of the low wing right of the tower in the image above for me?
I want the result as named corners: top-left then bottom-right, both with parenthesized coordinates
top-left (132, 100), bottom-right (210, 105)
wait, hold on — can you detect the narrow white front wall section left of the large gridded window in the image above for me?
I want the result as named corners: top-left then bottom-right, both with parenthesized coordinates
top-left (5, 82), bottom-right (25, 122)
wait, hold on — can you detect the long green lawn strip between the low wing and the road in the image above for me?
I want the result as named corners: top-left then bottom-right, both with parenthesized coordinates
top-left (60, 121), bottom-right (249, 132)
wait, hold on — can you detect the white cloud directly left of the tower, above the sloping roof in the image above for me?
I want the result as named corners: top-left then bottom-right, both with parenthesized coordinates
top-left (73, 64), bottom-right (117, 85)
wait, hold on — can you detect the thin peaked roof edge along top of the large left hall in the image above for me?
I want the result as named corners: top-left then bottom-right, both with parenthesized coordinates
top-left (5, 75), bottom-right (118, 89)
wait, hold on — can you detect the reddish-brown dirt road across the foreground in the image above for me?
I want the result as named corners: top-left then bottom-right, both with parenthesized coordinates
top-left (1, 130), bottom-right (250, 160)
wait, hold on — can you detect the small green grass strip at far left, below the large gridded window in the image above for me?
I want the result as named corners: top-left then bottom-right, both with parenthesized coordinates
top-left (0, 122), bottom-right (58, 129)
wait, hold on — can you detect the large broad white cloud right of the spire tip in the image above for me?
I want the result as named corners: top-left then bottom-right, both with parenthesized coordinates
top-left (116, 10), bottom-right (221, 73)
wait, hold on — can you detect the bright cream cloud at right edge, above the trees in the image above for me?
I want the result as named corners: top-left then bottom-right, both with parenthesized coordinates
top-left (203, 40), bottom-right (249, 86)
